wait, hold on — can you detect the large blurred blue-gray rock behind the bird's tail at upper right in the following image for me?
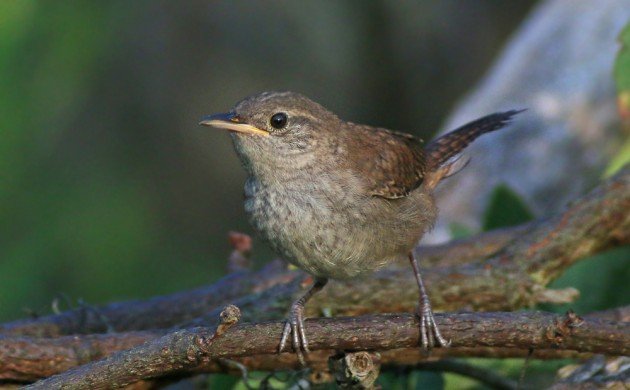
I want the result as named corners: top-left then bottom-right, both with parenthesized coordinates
top-left (426, 0), bottom-right (630, 242)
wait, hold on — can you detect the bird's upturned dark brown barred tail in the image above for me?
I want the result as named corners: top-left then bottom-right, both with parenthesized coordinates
top-left (425, 110), bottom-right (525, 187)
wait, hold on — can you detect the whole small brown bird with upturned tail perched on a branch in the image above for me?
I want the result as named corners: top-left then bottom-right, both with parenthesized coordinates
top-left (201, 92), bottom-right (520, 363)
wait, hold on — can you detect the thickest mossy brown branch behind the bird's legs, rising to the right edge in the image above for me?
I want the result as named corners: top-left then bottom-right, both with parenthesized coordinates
top-left (0, 168), bottom-right (630, 337)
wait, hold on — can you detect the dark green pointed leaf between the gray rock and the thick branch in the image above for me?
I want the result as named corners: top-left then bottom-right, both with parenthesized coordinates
top-left (483, 184), bottom-right (534, 231)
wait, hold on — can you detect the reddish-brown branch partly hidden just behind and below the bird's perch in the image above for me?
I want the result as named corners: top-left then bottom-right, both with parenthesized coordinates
top-left (0, 331), bottom-right (592, 382)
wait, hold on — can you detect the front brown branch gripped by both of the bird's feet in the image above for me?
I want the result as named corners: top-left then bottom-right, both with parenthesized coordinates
top-left (23, 312), bottom-right (630, 389)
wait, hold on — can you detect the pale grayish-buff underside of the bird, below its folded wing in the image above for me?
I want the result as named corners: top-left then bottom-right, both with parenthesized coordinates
top-left (245, 181), bottom-right (436, 279)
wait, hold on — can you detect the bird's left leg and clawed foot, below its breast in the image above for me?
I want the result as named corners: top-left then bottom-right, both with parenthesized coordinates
top-left (278, 279), bottom-right (328, 366)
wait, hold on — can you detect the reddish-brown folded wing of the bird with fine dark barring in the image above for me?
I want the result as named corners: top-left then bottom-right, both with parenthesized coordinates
top-left (349, 125), bottom-right (426, 199)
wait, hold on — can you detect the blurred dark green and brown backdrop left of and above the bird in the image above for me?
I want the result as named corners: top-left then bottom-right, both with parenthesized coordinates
top-left (0, 0), bottom-right (544, 321)
